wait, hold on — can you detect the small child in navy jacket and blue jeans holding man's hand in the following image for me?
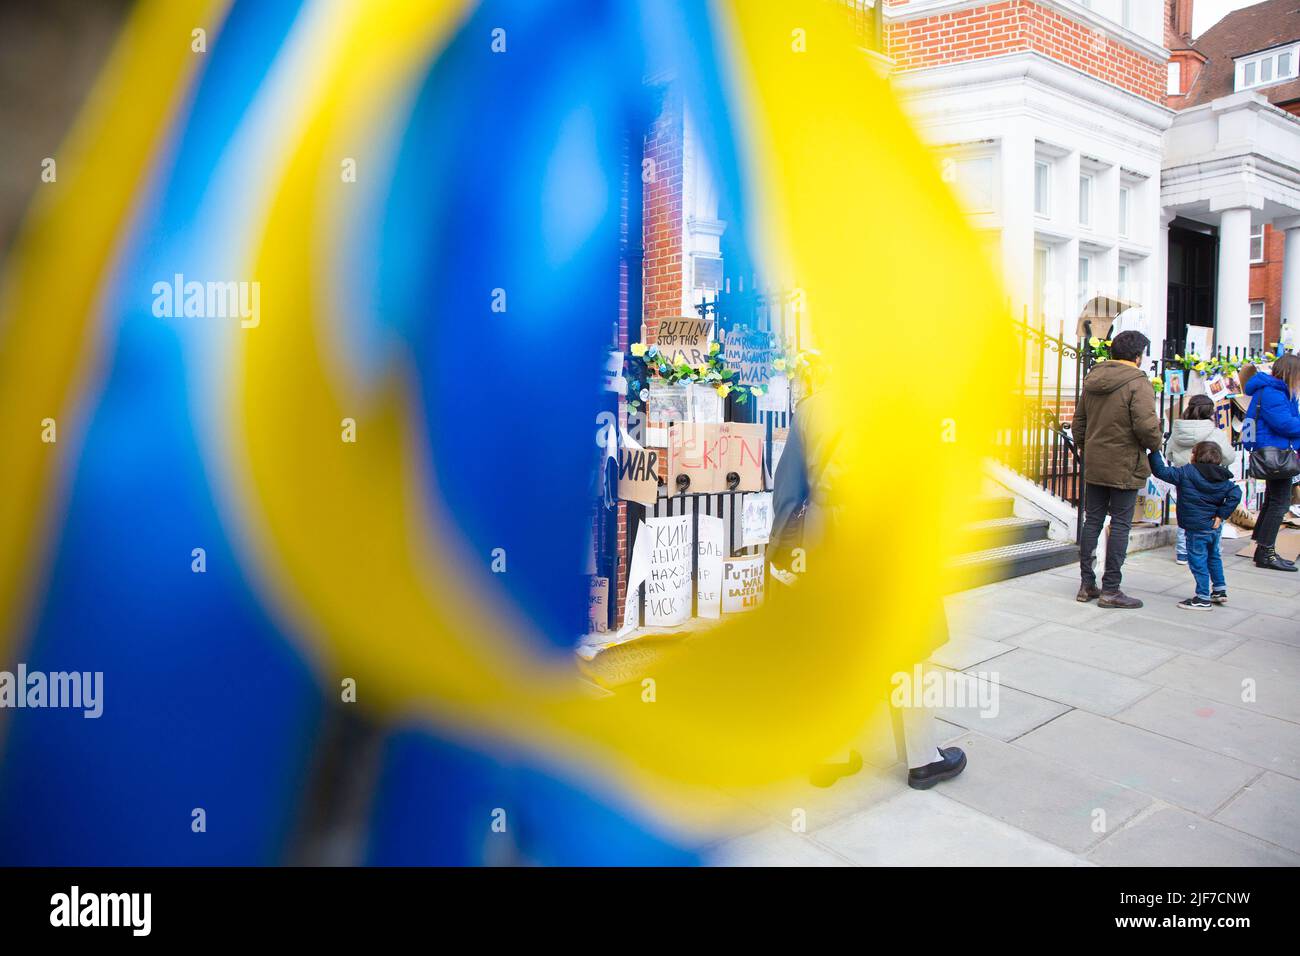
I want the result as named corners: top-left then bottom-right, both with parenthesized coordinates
top-left (1147, 441), bottom-right (1242, 611)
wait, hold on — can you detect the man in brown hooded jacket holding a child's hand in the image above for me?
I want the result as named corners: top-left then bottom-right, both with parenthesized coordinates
top-left (1074, 332), bottom-right (1164, 607)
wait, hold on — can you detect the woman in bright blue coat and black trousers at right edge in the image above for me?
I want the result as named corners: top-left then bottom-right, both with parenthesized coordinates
top-left (1244, 355), bottom-right (1300, 571)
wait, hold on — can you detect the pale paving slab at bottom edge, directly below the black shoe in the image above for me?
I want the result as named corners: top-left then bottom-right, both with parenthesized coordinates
top-left (815, 778), bottom-right (1087, 866)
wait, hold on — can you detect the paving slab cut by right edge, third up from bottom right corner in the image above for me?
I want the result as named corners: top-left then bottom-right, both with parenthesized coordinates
top-left (1115, 687), bottom-right (1300, 778)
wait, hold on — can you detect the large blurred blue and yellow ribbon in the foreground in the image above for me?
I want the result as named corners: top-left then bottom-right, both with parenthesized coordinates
top-left (0, 0), bottom-right (1011, 864)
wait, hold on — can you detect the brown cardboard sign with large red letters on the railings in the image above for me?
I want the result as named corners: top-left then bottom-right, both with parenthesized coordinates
top-left (668, 421), bottom-right (764, 494)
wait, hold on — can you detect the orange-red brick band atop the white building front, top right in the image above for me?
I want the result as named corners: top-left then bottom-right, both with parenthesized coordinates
top-left (887, 0), bottom-right (1166, 103)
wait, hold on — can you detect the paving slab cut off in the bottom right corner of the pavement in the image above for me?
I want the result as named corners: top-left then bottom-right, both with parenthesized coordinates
top-left (1088, 806), bottom-right (1300, 866)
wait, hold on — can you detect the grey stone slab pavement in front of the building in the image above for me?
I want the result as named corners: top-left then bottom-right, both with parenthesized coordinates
top-left (705, 548), bottom-right (1300, 866)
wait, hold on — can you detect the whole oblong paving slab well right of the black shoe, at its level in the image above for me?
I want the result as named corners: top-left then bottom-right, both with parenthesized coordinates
top-left (1015, 710), bottom-right (1260, 816)
